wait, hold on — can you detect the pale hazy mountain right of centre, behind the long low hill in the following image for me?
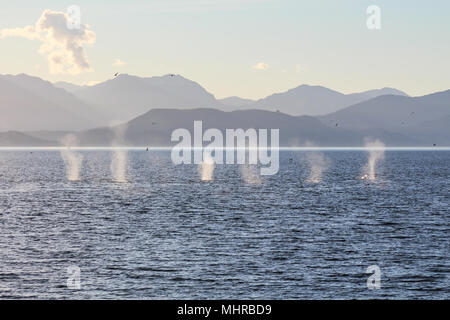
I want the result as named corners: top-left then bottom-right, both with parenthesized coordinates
top-left (250, 85), bottom-right (406, 116)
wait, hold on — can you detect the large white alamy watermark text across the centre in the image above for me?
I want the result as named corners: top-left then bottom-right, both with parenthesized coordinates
top-left (171, 121), bottom-right (280, 176)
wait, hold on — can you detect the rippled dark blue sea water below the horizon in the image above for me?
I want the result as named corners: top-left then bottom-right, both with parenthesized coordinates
top-left (0, 150), bottom-right (450, 299)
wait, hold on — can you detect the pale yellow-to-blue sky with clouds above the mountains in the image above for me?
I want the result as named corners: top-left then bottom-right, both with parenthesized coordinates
top-left (0, 0), bottom-right (450, 99)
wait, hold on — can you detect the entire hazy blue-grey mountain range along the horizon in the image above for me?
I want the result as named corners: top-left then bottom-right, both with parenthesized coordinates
top-left (0, 74), bottom-right (450, 146)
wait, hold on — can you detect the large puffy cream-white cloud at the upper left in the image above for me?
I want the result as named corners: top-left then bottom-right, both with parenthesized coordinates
top-left (0, 9), bottom-right (95, 74)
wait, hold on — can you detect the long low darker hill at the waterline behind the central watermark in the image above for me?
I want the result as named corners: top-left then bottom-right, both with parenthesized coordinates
top-left (72, 109), bottom-right (418, 147)
